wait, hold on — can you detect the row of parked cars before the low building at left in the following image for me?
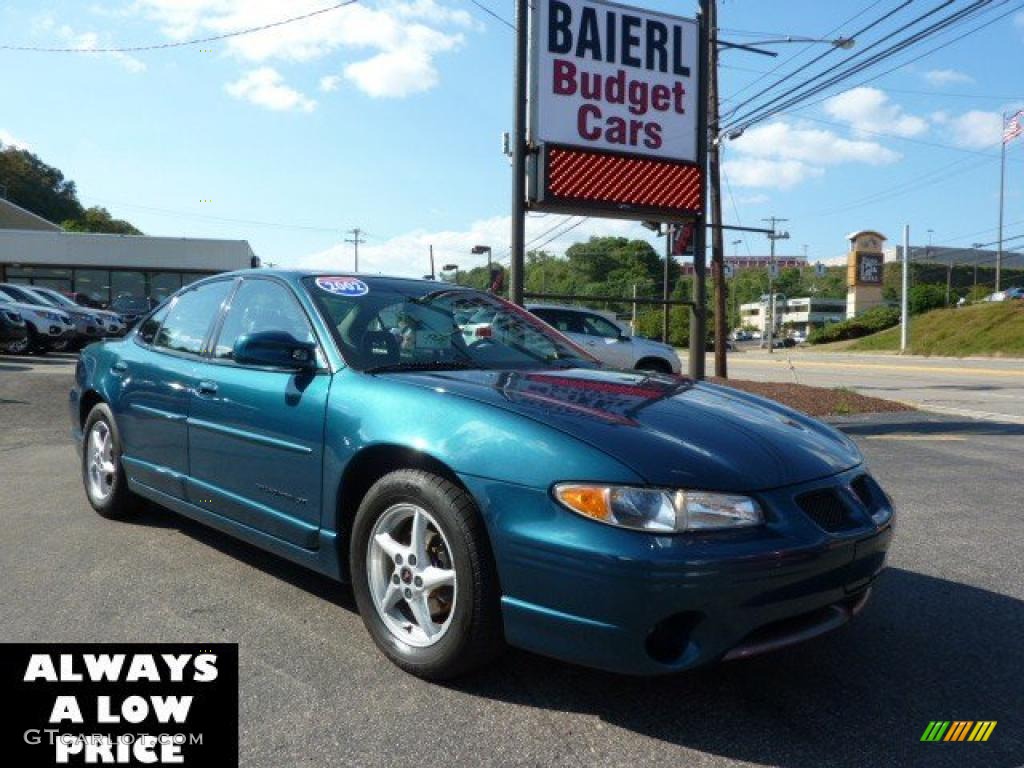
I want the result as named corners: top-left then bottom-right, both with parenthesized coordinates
top-left (0, 283), bottom-right (152, 354)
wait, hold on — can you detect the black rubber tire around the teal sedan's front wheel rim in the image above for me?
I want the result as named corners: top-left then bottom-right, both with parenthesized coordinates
top-left (349, 470), bottom-right (504, 680)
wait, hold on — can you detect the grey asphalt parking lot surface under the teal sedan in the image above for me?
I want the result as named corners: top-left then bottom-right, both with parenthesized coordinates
top-left (0, 356), bottom-right (1024, 768)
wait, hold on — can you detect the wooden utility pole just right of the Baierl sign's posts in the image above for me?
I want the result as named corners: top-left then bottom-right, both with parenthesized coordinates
top-left (708, 0), bottom-right (729, 379)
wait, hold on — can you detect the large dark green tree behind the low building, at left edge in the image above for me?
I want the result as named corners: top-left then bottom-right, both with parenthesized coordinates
top-left (0, 144), bottom-right (82, 223)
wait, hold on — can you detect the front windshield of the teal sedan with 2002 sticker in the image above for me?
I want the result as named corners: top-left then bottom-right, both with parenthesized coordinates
top-left (304, 278), bottom-right (596, 371)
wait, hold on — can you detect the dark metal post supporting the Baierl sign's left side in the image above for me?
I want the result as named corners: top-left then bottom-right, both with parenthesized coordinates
top-left (509, 0), bottom-right (529, 306)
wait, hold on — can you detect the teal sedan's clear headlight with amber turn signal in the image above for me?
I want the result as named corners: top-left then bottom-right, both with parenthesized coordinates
top-left (554, 482), bottom-right (764, 532)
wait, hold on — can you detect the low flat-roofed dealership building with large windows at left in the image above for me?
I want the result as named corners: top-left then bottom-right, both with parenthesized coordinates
top-left (0, 199), bottom-right (259, 306)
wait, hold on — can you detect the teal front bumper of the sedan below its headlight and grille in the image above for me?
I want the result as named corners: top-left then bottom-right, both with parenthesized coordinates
top-left (463, 468), bottom-right (892, 675)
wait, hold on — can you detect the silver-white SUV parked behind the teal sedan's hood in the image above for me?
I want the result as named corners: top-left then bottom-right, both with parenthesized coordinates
top-left (526, 304), bottom-right (681, 374)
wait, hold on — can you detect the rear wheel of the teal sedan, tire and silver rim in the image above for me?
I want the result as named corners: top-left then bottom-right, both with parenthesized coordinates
top-left (82, 402), bottom-right (138, 519)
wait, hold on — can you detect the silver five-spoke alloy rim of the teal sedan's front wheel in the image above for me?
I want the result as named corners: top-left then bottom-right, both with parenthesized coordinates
top-left (367, 503), bottom-right (458, 648)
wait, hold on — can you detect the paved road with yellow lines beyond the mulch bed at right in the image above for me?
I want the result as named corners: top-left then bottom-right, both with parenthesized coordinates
top-left (724, 349), bottom-right (1024, 424)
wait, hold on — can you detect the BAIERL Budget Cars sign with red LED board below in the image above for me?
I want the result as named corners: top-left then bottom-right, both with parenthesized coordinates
top-left (529, 0), bottom-right (702, 218)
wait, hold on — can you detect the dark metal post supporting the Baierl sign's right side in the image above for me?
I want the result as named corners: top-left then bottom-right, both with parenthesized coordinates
top-left (689, 0), bottom-right (711, 379)
